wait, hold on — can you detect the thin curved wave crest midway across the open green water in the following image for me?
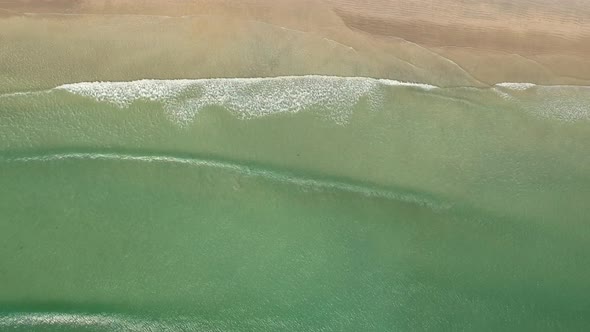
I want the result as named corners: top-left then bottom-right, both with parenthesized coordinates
top-left (0, 152), bottom-right (451, 210)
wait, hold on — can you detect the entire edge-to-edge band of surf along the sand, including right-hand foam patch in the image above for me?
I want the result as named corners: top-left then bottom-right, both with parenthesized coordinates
top-left (0, 75), bottom-right (590, 126)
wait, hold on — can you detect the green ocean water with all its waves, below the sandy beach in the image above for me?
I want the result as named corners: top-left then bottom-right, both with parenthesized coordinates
top-left (0, 76), bottom-right (590, 331)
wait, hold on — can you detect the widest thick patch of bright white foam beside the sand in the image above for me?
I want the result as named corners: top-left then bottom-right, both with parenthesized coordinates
top-left (55, 75), bottom-right (437, 123)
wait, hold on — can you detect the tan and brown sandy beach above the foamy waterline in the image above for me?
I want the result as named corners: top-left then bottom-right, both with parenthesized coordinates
top-left (0, 0), bottom-right (590, 90)
